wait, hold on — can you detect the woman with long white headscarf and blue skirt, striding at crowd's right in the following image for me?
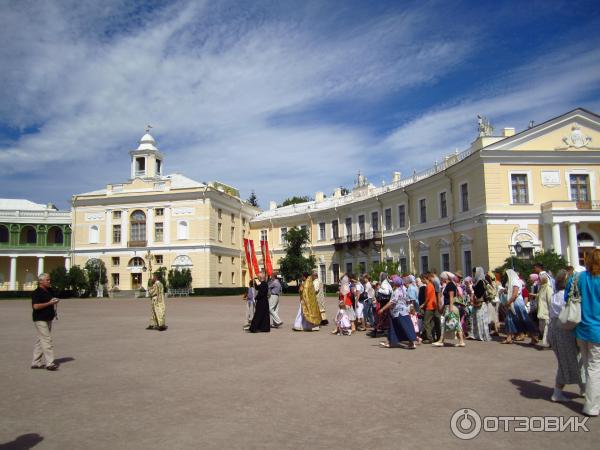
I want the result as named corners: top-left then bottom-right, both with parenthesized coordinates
top-left (502, 269), bottom-right (538, 345)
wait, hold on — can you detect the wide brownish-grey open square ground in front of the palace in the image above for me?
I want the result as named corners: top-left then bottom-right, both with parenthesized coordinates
top-left (0, 297), bottom-right (600, 450)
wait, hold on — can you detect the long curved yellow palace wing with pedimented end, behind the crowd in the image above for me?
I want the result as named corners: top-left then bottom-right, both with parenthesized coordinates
top-left (251, 108), bottom-right (600, 283)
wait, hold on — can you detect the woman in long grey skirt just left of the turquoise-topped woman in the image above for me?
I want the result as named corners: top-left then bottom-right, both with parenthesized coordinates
top-left (548, 270), bottom-right (585, 402)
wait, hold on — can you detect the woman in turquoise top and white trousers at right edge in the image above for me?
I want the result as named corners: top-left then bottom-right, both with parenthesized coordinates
top-left (567, 248), bottom-right (600, 416)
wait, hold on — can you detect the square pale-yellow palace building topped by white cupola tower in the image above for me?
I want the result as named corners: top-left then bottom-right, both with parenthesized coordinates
top-left (71, 129), bottom-right (259, 290)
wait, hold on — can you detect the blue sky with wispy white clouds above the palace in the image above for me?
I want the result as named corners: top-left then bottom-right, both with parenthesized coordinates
top-left (0, 0), bottom-right (600, 209)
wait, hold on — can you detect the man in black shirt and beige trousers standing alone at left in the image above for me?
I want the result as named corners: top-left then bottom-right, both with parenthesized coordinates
top-left (31, 273), bottom-right (58, 370)
